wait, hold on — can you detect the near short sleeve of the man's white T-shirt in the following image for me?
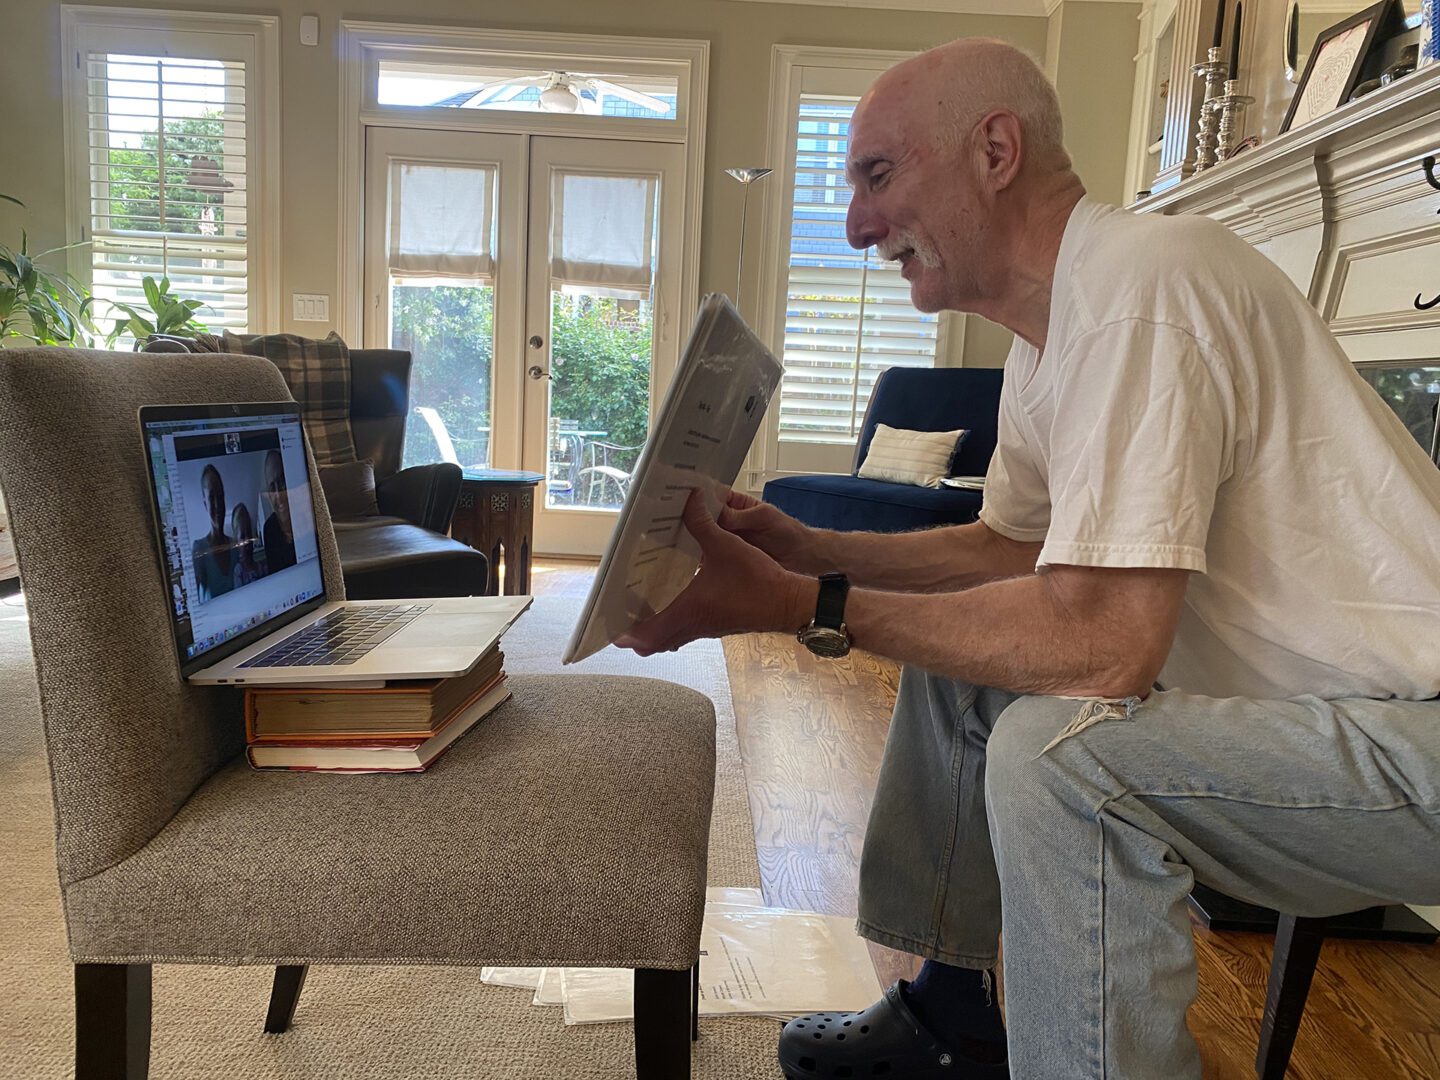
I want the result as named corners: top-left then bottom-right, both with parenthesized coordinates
top-left (1037, 320), bottom-right (1236, 573)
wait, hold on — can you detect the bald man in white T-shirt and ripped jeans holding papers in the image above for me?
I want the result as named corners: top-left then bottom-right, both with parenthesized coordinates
top-left (619, 40), bottom-right (1440, 1080)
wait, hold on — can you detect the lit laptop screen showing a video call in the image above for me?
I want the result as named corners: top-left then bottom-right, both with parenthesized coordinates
top-left (140, 402), bottom-right (325, 674)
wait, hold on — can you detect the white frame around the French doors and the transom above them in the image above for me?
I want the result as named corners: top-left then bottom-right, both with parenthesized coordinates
top-left (331, 19), bottom-right (710, 341)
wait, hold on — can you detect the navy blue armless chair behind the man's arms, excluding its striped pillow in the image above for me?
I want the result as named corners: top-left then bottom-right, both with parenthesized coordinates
top-left (762, 367), bottom-right (1004, 533)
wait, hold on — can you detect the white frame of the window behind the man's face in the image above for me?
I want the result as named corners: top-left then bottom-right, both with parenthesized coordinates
top-left (743, 45), bottom-right (965, 491)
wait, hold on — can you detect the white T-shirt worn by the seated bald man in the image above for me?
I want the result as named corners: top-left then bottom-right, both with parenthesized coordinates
top-left (981, 199), bottom-right (1440, 700)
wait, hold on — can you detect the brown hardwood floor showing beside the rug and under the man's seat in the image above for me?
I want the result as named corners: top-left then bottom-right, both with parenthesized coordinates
top-left (534, 562), bottom-right (1440, 1080)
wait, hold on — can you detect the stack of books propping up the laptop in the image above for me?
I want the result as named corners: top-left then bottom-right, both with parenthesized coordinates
top-left (245, 645), bottom-right (510, 772)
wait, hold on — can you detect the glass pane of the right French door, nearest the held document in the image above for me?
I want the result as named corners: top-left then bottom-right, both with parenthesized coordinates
top-left (546, 171), bottom-right (660, 510)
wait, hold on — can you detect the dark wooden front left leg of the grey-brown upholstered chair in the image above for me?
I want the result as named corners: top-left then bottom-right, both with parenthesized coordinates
top-left (75, 963), bottom-right (150, 1080)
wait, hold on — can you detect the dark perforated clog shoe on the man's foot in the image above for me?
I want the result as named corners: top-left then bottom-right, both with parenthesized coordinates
top-left (780, 979), bottom-right (1009, 1080)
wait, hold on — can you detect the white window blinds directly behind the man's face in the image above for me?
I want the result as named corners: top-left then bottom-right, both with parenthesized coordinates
top-left (779, 95), bottom-right (939, 444)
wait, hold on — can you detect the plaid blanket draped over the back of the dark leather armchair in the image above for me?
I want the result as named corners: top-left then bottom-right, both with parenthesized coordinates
top-left (223, 331), bottom-right (356, 465)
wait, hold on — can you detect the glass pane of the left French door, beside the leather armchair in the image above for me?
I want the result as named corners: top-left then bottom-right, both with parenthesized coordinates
top-left (389, 163), bottom-right (495, 467)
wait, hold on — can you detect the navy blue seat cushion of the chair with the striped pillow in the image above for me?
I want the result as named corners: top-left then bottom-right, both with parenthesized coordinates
top-left (762, 475), bottom-right (982, 533)
